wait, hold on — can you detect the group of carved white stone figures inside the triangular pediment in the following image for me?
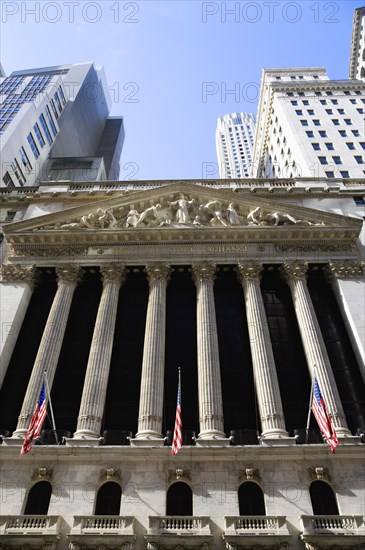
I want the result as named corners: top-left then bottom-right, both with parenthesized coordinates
top-left (40, 193), bottom-right (325, 231)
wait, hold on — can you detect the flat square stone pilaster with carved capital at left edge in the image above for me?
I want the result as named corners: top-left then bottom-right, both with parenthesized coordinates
top-left (0, 264), bottom-right (37, 388)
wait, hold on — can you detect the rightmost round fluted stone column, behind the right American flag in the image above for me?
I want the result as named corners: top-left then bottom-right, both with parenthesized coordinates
top-left (281, 261), bottom-right (351, 436)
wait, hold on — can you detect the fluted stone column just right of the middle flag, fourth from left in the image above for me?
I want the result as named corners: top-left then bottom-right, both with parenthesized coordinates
top-left (191, 263), bottom-right (225, 439)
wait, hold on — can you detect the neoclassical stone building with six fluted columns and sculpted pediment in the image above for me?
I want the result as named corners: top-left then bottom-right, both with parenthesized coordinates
top-left (0, 179), bottom-right (365, 550)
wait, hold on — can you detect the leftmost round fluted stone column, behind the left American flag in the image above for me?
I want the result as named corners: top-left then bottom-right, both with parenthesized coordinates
top-left (13, 265), bottom-right (81, 437)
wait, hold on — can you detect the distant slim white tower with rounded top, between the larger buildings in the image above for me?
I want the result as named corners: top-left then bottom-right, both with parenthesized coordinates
top-left (216, 113), bottom-right (255, 179)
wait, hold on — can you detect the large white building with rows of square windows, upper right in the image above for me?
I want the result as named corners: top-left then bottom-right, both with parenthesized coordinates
top-left (253, 68), bottom-right (365, 178)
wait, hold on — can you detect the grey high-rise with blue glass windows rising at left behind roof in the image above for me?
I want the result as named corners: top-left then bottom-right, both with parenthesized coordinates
top-left (0, 63), bottom-right (124, 187)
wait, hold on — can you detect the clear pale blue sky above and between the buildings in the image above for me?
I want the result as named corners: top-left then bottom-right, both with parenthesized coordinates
top-left (1, 0), bottom-right (362, 180)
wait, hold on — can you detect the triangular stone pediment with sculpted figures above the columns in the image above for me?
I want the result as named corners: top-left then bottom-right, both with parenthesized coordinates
top-left (3, 182), bottom-right (361, 256)
